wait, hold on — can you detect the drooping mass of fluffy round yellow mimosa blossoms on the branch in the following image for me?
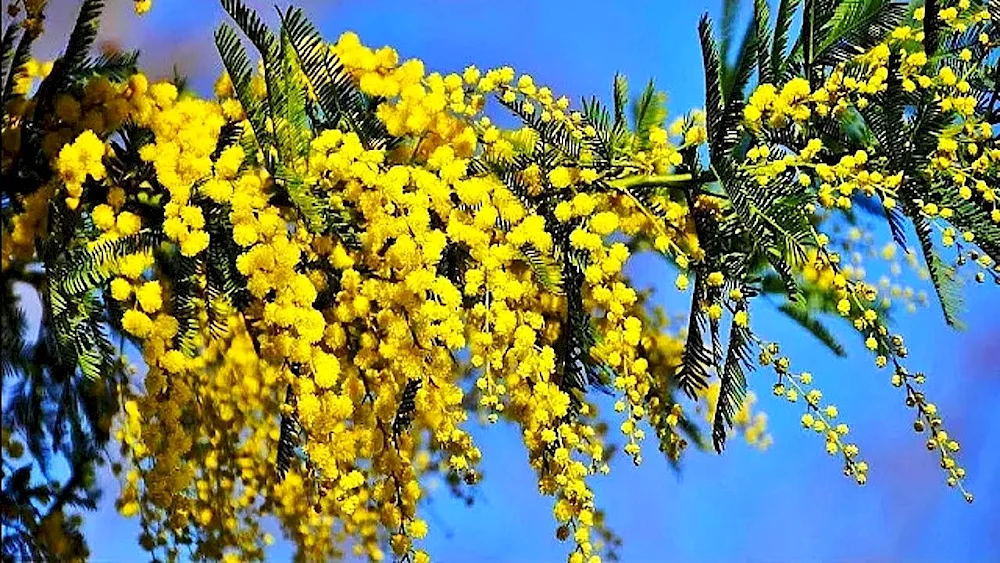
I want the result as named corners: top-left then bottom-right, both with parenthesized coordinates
top-left (2, 0), bottom-right (1000, 563)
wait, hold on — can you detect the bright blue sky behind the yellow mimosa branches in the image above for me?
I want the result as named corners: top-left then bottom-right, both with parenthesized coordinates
top-left (35, 0), bottom-right (1000, 563)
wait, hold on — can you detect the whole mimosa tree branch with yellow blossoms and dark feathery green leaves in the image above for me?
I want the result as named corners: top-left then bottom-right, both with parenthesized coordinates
top-left (0, 0), bottom-right (1000, 563)
